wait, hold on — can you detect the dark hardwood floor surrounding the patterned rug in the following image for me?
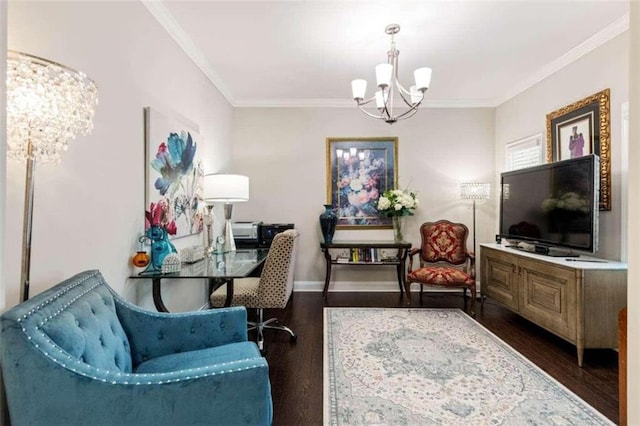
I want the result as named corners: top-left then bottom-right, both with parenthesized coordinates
top-left (252, 292), bottom-right (618, 426)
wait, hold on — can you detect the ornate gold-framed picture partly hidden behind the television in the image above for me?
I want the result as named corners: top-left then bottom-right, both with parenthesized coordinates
top-left (547, 89), bottom-right (611, 210)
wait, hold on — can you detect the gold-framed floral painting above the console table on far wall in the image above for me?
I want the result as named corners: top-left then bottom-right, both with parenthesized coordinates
top-left (327, 137), bottom-right (398, 229)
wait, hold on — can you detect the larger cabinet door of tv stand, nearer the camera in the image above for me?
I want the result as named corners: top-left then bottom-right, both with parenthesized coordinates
top-left (518, 258), bottom-right (577, 343)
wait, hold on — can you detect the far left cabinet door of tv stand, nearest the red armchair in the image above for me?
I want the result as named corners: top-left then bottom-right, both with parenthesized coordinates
top-left (481, 248), bottom-right (518, 312)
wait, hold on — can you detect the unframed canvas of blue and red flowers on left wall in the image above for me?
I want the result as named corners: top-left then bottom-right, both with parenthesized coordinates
top-left (144, 107), bottom-right (204, 238)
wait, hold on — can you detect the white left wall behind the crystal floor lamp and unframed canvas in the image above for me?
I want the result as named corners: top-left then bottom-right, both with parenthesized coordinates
top-left (2, 2), bottom-right (232, 310)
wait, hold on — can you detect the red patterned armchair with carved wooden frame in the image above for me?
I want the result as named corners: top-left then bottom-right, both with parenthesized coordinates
top-left (405, 220), bottom-right (476, 315)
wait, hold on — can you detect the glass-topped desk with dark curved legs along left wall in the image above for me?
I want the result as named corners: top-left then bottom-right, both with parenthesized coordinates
top-left (131, 249), bottom-right (269, 312)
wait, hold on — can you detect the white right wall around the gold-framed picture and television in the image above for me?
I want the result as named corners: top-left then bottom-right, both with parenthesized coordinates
top-left (496, 32), bottom-right (629, 260)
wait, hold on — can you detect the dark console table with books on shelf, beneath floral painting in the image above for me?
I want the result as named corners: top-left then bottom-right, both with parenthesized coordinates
top-left (320, 241), bottom-right (411, 300)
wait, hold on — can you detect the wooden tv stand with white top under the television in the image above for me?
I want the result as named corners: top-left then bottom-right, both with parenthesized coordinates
top-left (478, 244), bottom-right (627, 366)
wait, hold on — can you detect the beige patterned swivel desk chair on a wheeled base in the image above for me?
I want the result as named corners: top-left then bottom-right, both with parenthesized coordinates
top-left (210, 229), bottom-right (300, 351)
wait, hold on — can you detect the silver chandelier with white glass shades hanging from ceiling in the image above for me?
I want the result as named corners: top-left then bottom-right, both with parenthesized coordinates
top-left (351, 24), bottom-right (431, 124)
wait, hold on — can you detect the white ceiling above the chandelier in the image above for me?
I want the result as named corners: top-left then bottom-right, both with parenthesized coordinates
top-left (143, 0), bottom-right (629, 107)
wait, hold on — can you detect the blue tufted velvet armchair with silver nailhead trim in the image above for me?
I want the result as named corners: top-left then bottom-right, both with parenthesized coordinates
top-left (0, 271), bottom-right (272, 426)
